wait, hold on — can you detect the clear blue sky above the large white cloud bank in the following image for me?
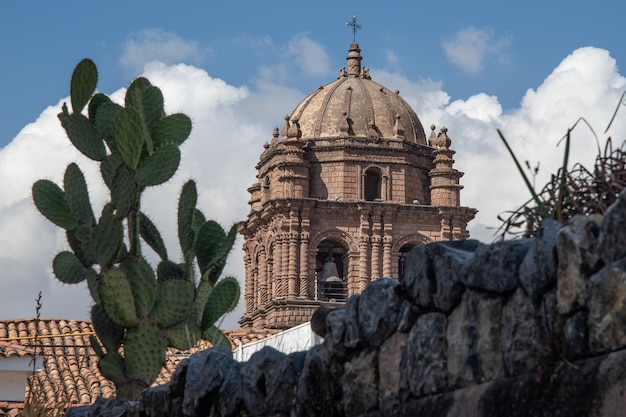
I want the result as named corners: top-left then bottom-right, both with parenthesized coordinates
top-left (0, 0), bottom-right (626, 146)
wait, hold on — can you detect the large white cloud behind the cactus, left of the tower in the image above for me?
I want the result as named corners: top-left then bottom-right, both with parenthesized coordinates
top-left (0, 62), bottom-right (296, 328)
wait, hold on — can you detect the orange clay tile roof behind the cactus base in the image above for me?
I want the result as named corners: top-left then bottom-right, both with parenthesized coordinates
top-left (0, 318), bottom-right (279, 416)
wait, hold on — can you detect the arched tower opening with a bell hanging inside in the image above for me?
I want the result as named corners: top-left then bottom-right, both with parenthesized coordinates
top-left (315, 239), bottom-right (348, 301)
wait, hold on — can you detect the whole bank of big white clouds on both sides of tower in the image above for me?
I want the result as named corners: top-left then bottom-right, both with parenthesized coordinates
top-left (0, 48), bottom-right (626, 328)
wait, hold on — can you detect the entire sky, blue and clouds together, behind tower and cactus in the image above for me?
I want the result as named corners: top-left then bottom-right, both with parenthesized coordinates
top-left (0, 0), bottom-right (626, 327)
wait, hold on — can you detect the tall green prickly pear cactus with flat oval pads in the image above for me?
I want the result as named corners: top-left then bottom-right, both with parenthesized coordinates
top-left (32, 59), bottom-right (240, 400)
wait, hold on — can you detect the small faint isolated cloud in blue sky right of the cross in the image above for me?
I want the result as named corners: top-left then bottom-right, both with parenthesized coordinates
top-left (442, 27), bottom-right (511, 74)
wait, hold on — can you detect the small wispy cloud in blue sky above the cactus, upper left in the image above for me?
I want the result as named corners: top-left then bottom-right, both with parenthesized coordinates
top-left (120, 29), bottom-right (202, 73)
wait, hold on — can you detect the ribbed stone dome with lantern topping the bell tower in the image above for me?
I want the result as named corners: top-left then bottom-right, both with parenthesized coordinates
top-left (289, 42), bottom-right (426, 145)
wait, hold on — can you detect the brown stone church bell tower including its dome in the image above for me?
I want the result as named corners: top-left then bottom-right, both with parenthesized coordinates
top-left (239, 43), bottom-right (476, 328)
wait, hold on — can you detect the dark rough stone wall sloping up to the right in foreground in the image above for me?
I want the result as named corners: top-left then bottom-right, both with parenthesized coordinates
top-left (64, 193), bottom-right (626, 417)
